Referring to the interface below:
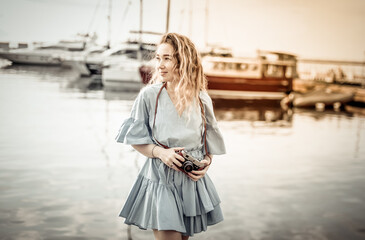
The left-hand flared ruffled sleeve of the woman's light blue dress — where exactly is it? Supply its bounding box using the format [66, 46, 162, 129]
[115, 89, 153, 145]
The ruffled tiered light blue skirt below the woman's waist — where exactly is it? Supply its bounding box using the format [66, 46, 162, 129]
[119, 152, 223, 236]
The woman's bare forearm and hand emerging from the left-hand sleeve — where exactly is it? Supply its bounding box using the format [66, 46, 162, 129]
[132, 144, 185, 171]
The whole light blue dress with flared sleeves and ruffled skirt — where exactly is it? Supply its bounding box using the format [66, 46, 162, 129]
[116, 83, 226, 236]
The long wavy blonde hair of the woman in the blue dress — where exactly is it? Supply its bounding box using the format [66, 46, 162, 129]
[150, 33, 207, 116]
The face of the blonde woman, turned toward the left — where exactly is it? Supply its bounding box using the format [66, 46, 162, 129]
[156, 43, 177, 82]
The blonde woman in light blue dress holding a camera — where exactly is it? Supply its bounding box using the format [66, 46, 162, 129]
[116, 33, 225, 240]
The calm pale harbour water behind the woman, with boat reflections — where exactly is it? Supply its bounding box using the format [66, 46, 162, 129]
[0, 67, 365, 240]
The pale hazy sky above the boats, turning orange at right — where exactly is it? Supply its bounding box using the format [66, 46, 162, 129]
[0, 0, 365, 61]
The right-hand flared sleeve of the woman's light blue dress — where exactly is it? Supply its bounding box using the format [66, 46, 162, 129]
[200, 91, 226, 155]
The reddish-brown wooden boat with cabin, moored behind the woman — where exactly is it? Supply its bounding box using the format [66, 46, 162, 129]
[203, 51, 297, 99]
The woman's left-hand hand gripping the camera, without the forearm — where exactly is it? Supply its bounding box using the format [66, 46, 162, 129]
[155, 147, 185, 171]
